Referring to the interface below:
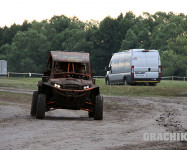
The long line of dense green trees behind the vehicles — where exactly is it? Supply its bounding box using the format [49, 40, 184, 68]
[0, 12, 187, 76]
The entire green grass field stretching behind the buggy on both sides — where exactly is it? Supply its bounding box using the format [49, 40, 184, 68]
[0, 78, 187, 96]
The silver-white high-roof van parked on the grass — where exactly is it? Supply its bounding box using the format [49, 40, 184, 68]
[105, 49, 161, 86]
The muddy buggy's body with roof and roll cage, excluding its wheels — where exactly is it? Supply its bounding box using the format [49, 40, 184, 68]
[38, 51, 100, 111]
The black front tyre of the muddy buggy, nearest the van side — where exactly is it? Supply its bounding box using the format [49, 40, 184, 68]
[94, 95, 103, 120]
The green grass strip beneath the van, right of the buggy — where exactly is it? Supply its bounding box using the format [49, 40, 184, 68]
[96, 79, 187, 96]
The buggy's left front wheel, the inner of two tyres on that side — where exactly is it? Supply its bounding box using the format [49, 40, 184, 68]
[36, 94, 46, 119]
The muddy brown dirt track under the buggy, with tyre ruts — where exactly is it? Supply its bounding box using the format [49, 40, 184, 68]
[0, 87, 187, 150]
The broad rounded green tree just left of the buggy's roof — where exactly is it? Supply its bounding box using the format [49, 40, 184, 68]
[8, 30, 49, 72]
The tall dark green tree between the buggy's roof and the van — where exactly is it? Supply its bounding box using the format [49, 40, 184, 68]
[92, 17, 120, 75]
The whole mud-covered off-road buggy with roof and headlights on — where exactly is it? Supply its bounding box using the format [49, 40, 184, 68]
[31, 51, 103, 120]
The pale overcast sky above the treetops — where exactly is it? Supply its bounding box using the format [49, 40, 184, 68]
[0, 0, 187, 27]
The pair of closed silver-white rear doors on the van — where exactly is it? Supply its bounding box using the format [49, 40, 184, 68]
[132, 50, 159, 79]
